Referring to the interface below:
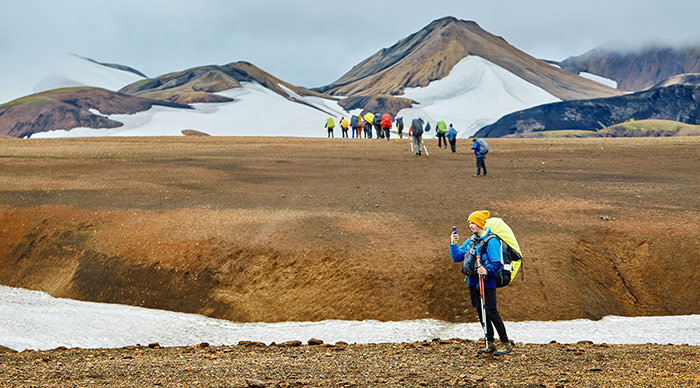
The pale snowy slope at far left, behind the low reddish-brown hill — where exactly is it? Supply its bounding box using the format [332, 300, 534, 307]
[0, 52, 143, 104]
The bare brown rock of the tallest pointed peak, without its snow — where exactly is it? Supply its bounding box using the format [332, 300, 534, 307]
[315, 17, 620, 107]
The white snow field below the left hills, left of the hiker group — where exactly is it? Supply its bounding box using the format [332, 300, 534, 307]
[32, 82, 349, 138]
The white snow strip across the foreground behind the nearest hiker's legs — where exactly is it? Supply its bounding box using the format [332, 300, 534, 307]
[0, 286, 700, 351]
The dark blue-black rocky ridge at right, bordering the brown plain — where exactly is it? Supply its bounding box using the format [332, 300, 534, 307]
[474, 85, 700, 137]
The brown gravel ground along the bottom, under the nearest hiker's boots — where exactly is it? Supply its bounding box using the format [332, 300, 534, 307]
[0, 339, 700, 387]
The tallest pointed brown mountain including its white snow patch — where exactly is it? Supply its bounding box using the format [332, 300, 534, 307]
[315, 17, 620, 137]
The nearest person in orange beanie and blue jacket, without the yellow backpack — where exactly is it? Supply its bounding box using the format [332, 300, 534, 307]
[450, 210, 513, 356]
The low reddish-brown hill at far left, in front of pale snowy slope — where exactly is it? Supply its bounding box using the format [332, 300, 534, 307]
[0, 87, 189, 138]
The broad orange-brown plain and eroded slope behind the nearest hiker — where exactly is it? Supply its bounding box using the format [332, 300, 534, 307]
[0, 136, 700, 321]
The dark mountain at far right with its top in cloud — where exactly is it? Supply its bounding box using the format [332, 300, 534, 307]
[558, 44, 700, 91]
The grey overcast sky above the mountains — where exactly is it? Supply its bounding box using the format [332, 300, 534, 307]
[0, 0, 700, 87]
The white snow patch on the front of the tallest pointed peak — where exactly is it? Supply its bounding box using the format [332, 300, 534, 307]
[397, 55, 561, 137]
